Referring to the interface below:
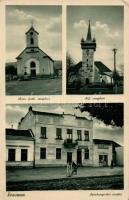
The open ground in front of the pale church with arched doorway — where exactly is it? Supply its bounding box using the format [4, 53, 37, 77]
[6, 78, 62, 95]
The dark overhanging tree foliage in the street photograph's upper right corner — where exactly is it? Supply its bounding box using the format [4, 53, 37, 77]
[76, 103, 124, 127]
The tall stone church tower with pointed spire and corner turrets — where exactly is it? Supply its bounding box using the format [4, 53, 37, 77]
[80, 20, 96, 85]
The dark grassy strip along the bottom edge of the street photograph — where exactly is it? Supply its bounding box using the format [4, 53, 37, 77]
[6, 175, 124, 191]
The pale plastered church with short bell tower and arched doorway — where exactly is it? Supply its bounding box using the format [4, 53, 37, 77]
[16, 25, 54, 78]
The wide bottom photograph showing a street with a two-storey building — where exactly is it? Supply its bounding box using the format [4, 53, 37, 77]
[5, 103, 124, 191]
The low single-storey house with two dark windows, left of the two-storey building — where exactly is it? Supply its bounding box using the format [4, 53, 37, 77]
[6, 129, 34, 167]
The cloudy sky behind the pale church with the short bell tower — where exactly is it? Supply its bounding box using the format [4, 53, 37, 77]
[6, 5, 62, 62]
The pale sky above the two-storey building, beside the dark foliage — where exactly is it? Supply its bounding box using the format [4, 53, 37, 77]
[6, 104, 123, 145]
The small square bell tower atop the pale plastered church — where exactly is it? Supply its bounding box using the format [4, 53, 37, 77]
[26, 25, 39, 47]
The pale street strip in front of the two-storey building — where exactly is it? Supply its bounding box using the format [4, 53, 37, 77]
[6, 167, 123, 182]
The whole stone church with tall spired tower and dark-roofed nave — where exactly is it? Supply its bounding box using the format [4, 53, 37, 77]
[71, 21, 112, 85]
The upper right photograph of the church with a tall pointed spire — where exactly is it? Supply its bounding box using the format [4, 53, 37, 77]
[66, 5, 124, 94]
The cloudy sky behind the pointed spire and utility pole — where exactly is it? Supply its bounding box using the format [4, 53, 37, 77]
[67, 6, 124, 71]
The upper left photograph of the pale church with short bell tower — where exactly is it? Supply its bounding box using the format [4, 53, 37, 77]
[5, 5, 62, 95]
